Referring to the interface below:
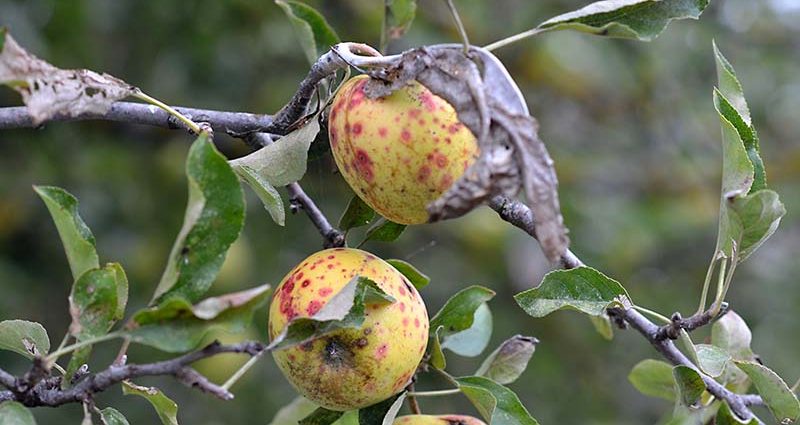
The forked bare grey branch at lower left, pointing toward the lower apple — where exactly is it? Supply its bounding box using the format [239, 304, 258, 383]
[0, 341, 266, 407]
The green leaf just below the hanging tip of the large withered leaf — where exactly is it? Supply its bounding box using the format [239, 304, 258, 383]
[514, 267, 630, 317]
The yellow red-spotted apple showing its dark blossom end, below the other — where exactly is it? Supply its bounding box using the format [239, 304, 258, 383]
[268, 248, 429, 411]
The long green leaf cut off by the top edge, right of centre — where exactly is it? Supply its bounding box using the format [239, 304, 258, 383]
[537, 0, 708, 41]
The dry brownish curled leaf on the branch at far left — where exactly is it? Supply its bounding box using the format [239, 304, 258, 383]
[0, 32, 138, 125]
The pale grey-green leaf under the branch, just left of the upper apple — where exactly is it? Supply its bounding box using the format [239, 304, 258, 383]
[230, 115, 319, 187]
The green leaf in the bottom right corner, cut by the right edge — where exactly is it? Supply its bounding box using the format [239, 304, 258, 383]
[735, 360, 800, 424]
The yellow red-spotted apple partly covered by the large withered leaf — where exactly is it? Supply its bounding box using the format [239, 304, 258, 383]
[328, 75, 479, 224]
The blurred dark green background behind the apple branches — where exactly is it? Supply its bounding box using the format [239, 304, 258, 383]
[0, 0, 800, 425]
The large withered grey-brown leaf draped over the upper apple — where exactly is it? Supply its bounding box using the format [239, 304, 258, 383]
[334, 43, 569, 261]
